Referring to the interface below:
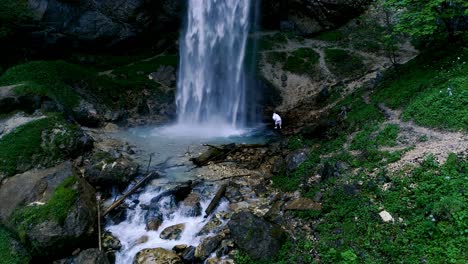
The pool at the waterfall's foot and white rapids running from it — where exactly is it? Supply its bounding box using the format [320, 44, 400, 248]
[105, 125, 273, 264]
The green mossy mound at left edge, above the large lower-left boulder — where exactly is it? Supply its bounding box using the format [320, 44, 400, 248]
[0, 115, 76, 176]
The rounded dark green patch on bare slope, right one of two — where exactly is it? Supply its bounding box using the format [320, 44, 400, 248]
[325, 48, 364, 78]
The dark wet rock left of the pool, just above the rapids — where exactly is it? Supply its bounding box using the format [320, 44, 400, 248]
[84, 152, 139, 189]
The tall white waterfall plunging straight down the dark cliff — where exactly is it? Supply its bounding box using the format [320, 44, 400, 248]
[176, 0, 252, 128]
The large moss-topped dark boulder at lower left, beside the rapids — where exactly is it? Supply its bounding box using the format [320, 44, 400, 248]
[8, 174, 97, 258]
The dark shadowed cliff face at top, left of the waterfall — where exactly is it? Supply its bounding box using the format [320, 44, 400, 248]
[29, 0, 182, 47]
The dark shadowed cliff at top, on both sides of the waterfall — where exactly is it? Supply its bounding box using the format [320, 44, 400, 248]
[23, 0, 371, 47]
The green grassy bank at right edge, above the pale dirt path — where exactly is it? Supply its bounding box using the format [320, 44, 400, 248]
[372, 47, 468, 131]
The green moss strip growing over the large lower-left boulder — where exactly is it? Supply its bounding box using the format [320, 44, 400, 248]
[10, 176, 78, 242]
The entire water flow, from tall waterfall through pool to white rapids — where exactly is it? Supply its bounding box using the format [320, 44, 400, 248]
[106, 0, 266, 264]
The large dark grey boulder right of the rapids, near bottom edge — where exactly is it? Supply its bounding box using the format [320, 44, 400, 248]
[228, 212, 286, 260]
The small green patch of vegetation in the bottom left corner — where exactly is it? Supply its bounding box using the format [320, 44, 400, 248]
[0, 226, 30, 264]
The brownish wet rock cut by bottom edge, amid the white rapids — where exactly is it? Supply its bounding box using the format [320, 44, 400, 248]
[133, 248, 183, 264]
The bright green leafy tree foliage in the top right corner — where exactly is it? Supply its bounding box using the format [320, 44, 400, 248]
[385, 0, 468, 40]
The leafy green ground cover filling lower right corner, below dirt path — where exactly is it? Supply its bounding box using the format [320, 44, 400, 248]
[268, 154, 468, 264]
